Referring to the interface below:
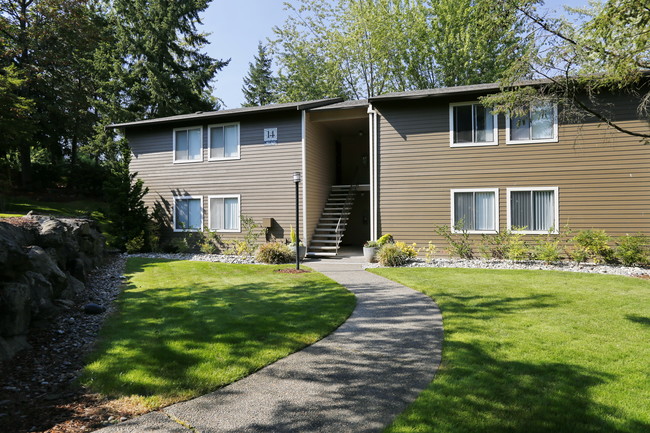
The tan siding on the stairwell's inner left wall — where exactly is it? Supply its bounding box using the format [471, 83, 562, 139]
[305, 113, 336, 246]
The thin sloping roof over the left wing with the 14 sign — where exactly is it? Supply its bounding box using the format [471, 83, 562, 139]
[107, 98, 343, 128]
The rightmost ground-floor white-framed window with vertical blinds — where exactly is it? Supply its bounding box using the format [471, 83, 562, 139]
[507, 186, 559, 234]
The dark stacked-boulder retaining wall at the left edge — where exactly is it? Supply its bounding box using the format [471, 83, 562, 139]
[0, 215, 105, 360]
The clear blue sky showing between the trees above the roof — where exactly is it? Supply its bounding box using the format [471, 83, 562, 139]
[202, 0, 587, 108]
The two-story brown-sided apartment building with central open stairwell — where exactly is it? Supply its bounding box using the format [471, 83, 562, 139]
[113, 80, 650, 253]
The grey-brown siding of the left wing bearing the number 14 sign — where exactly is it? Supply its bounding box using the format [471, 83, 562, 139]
[126, 111, 302, 239]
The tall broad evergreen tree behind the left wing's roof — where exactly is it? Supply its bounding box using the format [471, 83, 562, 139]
[97, 0, 229, 122]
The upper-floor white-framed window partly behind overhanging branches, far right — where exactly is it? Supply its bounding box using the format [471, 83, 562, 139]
[506, 102, 558, 144]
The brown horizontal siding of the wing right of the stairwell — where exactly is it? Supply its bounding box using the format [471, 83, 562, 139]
[376, 98, 650, 252]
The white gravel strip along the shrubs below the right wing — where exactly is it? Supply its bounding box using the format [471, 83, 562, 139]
[365, 259, 650, 277]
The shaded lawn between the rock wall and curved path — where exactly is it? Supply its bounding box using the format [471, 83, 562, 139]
[82, 258, 355, 409]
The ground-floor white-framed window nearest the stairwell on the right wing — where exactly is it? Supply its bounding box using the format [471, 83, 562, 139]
[451, 188, 499, 233]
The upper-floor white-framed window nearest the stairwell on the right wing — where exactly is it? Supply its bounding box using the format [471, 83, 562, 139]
[449, 102, 499, 147]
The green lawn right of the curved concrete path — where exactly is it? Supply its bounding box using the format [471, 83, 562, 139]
[372, 268, 650, 433]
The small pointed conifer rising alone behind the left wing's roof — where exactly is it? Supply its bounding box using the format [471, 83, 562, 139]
[242, 42, 277, 107]
